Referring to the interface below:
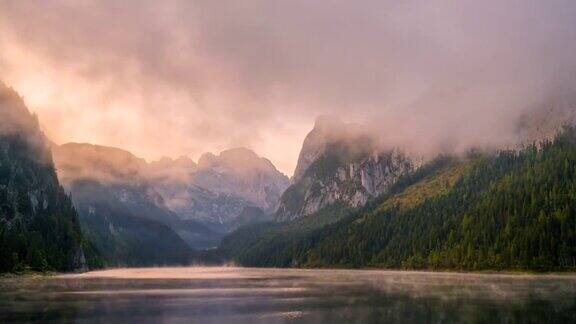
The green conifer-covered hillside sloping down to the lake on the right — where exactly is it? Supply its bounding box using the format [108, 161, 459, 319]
[223, 127, 576, 270]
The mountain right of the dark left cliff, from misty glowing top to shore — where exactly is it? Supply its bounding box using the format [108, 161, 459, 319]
[53, 143, 219, 266]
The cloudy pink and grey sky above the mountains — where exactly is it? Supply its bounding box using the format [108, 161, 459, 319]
[0, 0, 576, 175]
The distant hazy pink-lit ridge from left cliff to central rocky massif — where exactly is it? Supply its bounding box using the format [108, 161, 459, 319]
[54, 143, 288, 233]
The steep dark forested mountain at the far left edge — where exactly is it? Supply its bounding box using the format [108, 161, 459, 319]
[0, 83, 100, 272]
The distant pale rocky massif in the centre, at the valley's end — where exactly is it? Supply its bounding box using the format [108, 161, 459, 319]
[150, 148, 289, 232]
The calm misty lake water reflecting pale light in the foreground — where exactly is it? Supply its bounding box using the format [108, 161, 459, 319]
[0, 268, 576, 323]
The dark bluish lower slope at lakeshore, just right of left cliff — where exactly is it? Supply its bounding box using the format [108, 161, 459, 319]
[70, 179, 194, 266]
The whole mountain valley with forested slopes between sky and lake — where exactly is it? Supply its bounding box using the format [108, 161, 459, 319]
[0, 79, 576, 271]
